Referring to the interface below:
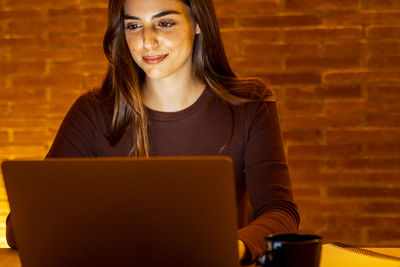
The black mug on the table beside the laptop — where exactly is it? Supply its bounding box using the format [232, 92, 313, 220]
[258, 234, 322, 267]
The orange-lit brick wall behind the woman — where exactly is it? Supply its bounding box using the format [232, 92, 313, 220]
[0, 0, 400, 246]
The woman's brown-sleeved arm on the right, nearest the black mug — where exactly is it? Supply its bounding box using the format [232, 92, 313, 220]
[239, 102, 300, 262]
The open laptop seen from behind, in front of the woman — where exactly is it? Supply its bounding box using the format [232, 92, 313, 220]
[2, 156, 239, 267]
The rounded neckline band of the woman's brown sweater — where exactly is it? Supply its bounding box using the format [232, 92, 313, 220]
[145, 86, 209, 121]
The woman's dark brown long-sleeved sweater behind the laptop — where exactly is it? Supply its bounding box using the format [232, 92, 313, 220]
[7, 88, 299, 260]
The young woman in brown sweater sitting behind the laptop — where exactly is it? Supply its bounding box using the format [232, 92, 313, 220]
[7, 0, 299, 262]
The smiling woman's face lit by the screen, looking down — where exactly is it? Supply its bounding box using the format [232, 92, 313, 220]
[124, 0, 199, 79]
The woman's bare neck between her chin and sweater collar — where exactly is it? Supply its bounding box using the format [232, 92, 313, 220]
[143, 69, 205, 112]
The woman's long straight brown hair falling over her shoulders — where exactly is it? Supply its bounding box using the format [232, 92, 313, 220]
[102, 0, 273, 156]
